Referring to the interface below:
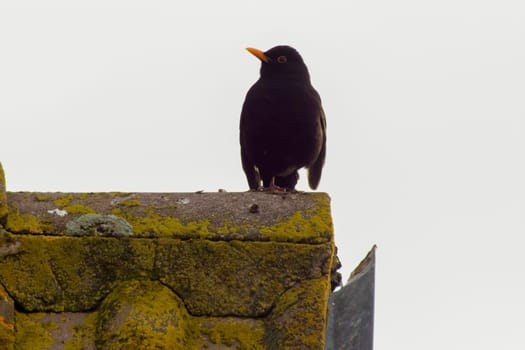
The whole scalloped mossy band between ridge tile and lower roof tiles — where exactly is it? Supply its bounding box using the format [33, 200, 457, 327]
[0, 230, 333, 317]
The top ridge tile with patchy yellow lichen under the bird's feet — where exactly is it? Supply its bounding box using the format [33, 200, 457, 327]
[3, 192, 333, 244]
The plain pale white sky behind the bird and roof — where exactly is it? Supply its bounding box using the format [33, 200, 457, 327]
[0, 0, 525, 350]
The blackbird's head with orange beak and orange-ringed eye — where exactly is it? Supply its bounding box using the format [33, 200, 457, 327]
[246, 45, 310, 81]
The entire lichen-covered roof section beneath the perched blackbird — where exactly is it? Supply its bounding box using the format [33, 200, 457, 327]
[0, 165, 336, 349]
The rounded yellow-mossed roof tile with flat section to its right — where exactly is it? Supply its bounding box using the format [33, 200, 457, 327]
[96, 280, 264, 350]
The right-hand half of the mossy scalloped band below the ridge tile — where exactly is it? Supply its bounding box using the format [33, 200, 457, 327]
[155, 239, 332, 317]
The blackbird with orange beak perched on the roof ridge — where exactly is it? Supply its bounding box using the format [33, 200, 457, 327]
[240, 46, 326, 192]
